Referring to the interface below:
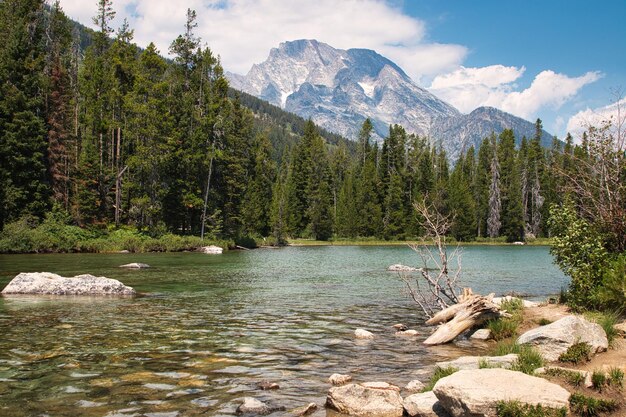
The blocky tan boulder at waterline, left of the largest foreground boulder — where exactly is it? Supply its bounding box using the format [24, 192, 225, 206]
[326, 382, 403, 417]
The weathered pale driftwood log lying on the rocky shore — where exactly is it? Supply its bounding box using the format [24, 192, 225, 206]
[424, 291, 510, 345]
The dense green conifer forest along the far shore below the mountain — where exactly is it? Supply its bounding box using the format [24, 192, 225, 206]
[0, 0, 588, 247]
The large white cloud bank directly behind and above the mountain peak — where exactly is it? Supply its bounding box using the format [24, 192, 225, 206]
[61, 0, 467, 81]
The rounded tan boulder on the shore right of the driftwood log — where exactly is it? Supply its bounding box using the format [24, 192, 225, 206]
[517, 316, 609, 361]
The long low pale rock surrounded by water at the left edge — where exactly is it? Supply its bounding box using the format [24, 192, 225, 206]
[2, 272, 135, 295]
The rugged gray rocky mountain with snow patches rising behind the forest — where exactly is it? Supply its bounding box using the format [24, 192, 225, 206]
[227, 40, 551, 160]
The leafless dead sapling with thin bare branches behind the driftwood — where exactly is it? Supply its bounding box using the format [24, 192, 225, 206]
[400, 197, 461, 318]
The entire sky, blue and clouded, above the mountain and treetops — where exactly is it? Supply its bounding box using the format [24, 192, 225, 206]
[60, 0, 626, 138]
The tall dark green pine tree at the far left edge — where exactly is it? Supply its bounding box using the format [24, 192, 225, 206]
[0, 0, 48, 228]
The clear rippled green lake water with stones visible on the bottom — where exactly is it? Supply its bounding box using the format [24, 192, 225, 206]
[0, 246, 567, 417]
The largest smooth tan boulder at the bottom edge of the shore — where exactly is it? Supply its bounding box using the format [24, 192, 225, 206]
[433, 369, 569, 417]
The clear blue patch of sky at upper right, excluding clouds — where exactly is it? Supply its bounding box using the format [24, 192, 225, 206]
[402, 0, 626, 133]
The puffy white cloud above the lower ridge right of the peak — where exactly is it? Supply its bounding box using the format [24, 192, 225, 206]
[430, 65, 601, 119]
